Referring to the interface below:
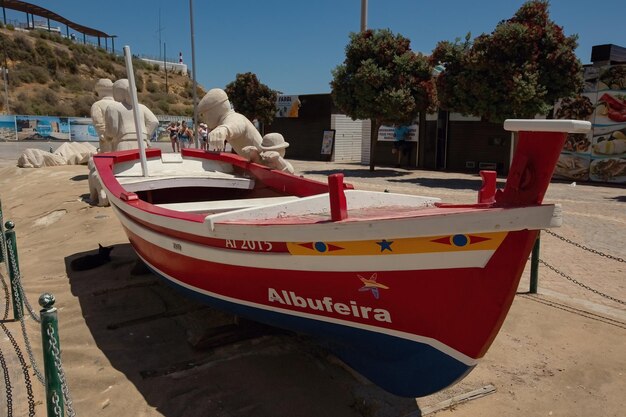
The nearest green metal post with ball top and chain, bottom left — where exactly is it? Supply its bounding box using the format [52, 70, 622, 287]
[39, 293, 65, 417]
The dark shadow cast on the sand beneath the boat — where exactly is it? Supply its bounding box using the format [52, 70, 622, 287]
[65, 244, 420, 417]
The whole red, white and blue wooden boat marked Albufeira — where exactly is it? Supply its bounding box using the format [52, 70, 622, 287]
[94, 120, 590, 397]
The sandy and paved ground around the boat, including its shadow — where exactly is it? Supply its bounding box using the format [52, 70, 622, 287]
[0, 144, 626, 417]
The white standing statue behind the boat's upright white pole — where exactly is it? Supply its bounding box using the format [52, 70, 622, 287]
[104, 78, 159, 151]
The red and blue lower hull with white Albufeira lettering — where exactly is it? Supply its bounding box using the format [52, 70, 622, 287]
[115, 207, 536, 397]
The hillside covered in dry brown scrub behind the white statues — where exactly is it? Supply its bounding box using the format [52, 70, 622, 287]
[0, 27, 204, 116]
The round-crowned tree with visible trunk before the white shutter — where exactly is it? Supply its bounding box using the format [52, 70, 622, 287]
[330, 29, 436, 170]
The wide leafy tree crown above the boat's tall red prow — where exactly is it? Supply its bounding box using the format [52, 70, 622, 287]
[431, 0, 582, 122]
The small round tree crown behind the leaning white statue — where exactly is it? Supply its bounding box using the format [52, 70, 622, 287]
[224, 72, 278, 124]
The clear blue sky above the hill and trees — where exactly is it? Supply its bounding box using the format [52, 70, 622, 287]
[7, 0, 626, 94]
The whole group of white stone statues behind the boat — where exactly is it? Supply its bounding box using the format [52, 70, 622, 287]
[89, 79, 294, 206]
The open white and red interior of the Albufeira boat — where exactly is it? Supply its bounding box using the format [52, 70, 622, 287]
[107, 154, 439, 217]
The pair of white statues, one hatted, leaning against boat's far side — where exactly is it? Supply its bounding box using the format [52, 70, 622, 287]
[198, 88, 293, 173]
